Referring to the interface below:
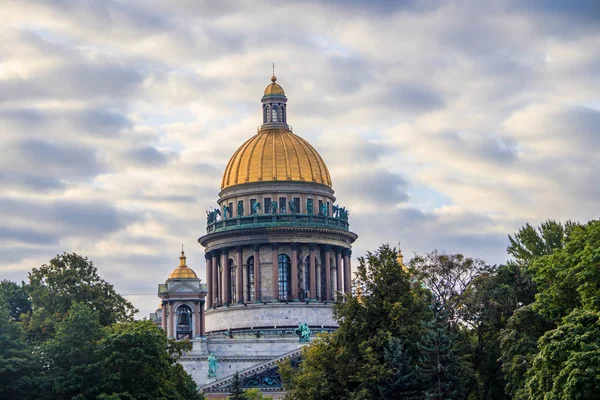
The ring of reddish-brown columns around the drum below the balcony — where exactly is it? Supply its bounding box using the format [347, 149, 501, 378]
[205, 243, 352, 308]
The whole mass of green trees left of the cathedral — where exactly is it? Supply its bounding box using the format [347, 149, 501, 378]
[0, 253, 203, 400]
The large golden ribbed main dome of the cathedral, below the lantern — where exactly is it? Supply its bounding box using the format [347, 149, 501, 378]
[221, 129, 331, 189]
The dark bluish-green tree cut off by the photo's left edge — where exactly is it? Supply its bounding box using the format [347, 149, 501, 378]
[0, 307, 33, 399]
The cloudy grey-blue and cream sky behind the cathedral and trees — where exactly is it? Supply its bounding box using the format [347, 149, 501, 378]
[0, 0, 600, 315]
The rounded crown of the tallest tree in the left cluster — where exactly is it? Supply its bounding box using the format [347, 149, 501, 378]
[23, 253, 137, 342]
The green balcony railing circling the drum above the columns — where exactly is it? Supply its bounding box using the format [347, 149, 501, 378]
[206, 214, 349, 233]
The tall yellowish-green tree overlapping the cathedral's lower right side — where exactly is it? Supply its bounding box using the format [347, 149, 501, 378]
[280, 245, 431, 399]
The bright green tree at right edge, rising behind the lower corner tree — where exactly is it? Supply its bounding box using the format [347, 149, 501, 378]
[501, 221, 600, 399]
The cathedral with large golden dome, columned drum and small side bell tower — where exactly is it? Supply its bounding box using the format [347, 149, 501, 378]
[151, 76, 357, 398]
